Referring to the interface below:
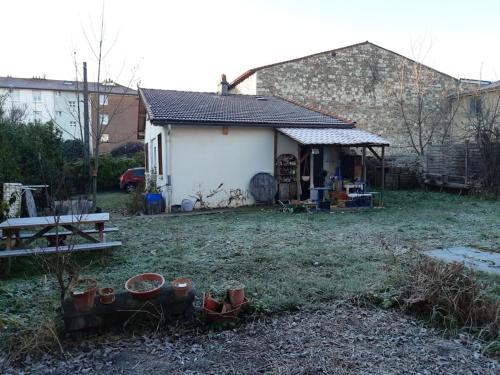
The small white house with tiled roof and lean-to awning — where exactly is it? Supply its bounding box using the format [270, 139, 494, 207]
[138, 77, 388, 210]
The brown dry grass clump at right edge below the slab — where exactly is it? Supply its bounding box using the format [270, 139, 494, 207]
[403, 257, 500, 340]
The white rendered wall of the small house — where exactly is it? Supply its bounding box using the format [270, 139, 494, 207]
[144, 121, 274, 207]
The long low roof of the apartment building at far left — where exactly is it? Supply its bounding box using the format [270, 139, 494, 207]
[0, 77, 137, 95]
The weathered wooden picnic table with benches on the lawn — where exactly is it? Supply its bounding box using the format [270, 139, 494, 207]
[0, 213, 122, 274]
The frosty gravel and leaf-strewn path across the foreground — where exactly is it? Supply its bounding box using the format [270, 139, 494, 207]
[3, 306, 500, 375]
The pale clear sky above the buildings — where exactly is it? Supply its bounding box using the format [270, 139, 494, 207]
[0, 0, 500, 91]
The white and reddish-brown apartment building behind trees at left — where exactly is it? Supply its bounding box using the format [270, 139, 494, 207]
[0, 77, 138, 152]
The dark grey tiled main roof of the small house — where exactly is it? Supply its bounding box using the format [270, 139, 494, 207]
[139, 89, 354, 128]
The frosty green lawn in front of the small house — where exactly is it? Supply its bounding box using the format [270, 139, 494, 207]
[0, 191, 500, 342]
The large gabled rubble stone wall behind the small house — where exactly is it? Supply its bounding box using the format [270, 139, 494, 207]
[233, 42, 458, 155]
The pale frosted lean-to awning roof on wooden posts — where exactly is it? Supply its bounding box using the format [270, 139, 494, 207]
[278, 128, 389, 146]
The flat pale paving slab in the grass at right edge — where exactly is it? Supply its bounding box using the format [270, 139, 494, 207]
[425, 246, 500, 275]
